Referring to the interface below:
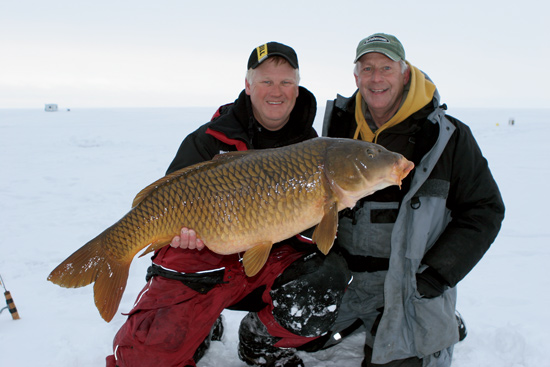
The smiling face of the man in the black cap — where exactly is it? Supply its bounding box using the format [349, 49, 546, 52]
[245, 59, 298, 131]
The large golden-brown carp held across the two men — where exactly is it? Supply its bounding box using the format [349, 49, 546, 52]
[48, 138, 414, 322]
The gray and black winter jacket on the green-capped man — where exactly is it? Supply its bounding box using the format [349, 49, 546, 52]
[323, 84, 504, 366]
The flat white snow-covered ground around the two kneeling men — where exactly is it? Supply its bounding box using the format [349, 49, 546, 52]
[0, 107, 550, 367]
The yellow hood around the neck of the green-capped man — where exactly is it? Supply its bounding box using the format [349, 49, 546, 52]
[353, 62, 435, 143]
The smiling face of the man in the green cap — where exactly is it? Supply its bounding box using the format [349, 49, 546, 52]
[355, 52, 410, 126]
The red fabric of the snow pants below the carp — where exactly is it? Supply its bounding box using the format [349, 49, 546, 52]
[107, 245, 315, 367]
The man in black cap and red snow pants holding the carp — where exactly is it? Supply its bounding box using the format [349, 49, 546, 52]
[107, 42, 350, 367]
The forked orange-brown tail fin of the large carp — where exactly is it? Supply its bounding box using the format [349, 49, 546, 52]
[48, 232, 133, 322]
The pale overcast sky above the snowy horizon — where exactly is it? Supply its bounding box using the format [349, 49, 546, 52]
[0, 0, 550, 108]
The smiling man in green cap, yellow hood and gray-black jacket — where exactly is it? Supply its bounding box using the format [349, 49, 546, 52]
[316, 33, 504, 367]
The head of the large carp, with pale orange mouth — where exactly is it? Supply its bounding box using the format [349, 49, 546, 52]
[325, 139, 414, 210]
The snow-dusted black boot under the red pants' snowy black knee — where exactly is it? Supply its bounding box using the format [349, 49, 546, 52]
[239, 312, 304, 367]
